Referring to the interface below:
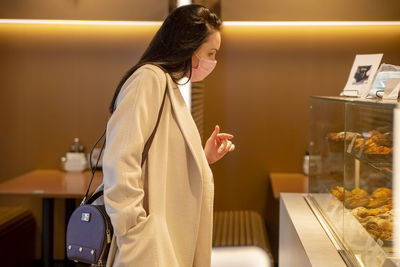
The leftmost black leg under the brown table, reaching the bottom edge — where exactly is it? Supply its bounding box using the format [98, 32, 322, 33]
[42, 198, 54, 267]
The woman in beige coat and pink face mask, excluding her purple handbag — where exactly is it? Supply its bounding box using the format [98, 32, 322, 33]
[103, 5, 235, 267]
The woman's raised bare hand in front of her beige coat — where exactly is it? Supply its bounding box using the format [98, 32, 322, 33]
[204, 125, 235, 164]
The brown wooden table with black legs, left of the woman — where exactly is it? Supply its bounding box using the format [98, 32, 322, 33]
[0, 170, 103, 267]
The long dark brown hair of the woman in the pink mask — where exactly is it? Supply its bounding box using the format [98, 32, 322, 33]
[110, 5, 222, 113]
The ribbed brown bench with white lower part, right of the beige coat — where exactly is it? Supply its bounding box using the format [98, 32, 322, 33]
[211, 210, 273, 267]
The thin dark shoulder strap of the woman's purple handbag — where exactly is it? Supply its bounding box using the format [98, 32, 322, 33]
[80, 76, 168, 205]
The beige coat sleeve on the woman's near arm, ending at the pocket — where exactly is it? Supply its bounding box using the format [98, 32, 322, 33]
[103, 66, 166, 237]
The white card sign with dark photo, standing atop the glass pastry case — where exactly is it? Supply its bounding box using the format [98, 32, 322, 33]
[341, 54, 383, 98]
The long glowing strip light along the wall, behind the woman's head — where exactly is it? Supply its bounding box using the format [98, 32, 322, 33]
[0, 19, 400, 27]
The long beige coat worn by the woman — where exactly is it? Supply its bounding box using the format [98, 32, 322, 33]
[103, 65, 214, 267]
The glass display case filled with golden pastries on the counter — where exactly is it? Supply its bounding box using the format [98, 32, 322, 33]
[306, 97, 400, 266]
